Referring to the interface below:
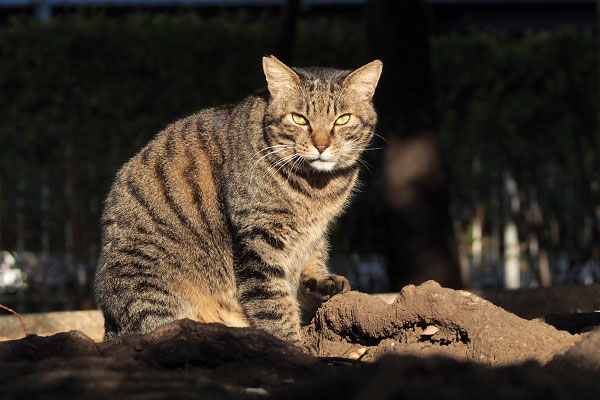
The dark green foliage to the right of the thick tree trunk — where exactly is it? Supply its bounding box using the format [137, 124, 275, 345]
[432, 31, 599, 181]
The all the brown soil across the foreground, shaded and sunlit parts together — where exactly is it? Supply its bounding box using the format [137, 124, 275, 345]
[0, 281, 600, 400]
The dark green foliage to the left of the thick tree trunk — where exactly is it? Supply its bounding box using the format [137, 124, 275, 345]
[0, 12, 362, 253]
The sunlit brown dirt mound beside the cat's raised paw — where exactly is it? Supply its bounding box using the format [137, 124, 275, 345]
[303, 281, 579, 365]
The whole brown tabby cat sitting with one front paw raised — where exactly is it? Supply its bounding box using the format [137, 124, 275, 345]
[94, 56, 383, 343]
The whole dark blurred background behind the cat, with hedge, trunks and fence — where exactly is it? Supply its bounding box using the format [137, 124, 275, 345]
[0, 0, 600, 312]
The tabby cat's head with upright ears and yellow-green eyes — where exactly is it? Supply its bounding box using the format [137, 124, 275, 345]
[263, 56, 383, 172]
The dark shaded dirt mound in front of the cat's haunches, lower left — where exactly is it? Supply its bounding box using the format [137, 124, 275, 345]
[0, 320, 325, 399]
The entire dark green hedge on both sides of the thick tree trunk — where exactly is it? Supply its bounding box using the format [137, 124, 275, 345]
[0, 13, 600, 288]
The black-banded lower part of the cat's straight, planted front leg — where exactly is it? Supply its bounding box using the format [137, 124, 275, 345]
[235, 249, 301, 344]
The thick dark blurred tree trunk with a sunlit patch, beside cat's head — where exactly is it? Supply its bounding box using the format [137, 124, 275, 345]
[367, 0, 461, 290]
